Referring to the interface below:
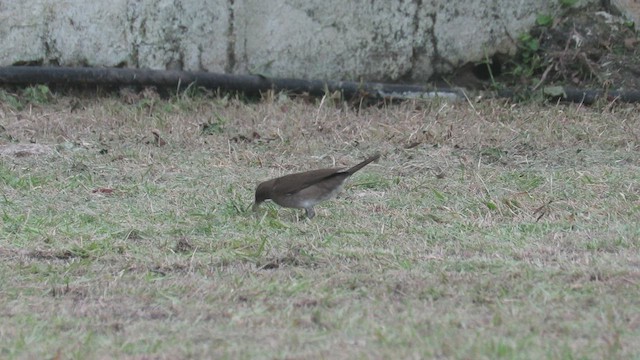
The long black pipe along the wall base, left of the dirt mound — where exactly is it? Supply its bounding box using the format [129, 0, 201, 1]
[0, 66, 464, 99]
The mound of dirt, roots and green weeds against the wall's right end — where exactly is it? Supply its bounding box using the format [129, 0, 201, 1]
[456, 4, 640, 93]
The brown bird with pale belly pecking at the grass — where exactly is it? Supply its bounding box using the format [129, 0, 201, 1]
[253, 154, 380, 219]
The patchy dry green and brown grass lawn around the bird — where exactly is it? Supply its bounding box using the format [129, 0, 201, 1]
[0, 91, 640, 359]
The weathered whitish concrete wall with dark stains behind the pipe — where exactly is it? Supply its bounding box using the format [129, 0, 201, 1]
[0, 0, 600, 81]
